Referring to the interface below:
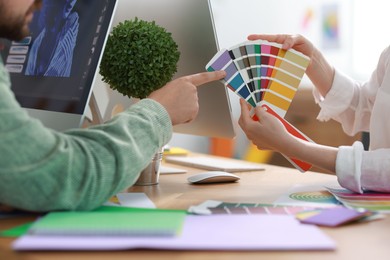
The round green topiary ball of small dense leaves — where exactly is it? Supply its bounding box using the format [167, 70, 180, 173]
[100, 18, 180, 98]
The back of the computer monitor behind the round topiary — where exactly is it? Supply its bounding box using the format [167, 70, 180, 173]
[100, 0, 235, 138]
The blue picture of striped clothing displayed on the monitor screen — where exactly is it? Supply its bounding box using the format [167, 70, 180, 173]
[25, 0, 79, 77]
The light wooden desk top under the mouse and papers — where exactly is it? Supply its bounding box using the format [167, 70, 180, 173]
[0, 155, 390, 260]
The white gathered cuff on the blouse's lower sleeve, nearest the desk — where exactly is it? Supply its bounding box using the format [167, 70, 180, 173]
[336, 141, 364, 193]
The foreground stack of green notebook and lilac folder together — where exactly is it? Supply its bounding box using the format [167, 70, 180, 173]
[7, 194, 336, 251]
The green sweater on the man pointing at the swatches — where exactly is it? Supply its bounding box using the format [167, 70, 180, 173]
[0, 60, 172, 211]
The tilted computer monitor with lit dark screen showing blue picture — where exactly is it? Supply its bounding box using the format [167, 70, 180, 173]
[0, 0, 117, 130]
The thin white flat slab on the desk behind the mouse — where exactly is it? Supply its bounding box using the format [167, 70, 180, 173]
[165, 156, 265, 172]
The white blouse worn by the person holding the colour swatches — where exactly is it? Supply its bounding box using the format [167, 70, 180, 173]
[313, 47, 390, 193]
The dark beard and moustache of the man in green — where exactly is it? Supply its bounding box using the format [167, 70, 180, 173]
[0, 0, 42, 41]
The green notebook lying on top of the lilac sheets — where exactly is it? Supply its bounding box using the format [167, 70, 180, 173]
[28, 207, 186, 236]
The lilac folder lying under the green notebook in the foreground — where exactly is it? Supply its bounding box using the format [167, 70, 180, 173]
[13, 215, 336, 250]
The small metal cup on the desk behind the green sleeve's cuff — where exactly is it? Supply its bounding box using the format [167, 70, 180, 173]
[134, 150, 163, 186]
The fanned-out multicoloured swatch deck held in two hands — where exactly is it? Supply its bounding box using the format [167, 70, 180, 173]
[206, 40, 312, 172]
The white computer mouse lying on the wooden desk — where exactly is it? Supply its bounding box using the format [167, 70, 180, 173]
[187, 171, 240, 184]
